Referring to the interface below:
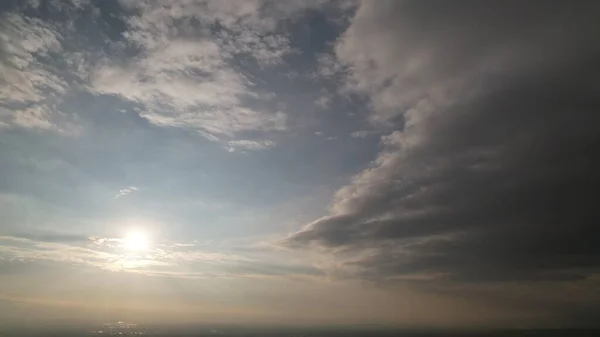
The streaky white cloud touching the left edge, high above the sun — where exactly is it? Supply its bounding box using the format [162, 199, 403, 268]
[0, 13, 82, 136]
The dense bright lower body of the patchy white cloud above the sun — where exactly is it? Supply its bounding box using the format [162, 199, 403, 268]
[92, 40, 278, 135]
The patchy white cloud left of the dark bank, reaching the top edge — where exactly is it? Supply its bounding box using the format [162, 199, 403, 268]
[90, 1, 314, 138]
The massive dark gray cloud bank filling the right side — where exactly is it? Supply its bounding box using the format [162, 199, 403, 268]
[286, 1, 600, 282]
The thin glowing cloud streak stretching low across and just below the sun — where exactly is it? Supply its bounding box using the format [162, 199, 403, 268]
[0, 235, 322, 278]
